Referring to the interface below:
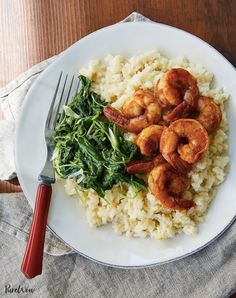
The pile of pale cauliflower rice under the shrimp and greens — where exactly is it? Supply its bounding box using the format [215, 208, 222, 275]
[65, 50, 229, 239]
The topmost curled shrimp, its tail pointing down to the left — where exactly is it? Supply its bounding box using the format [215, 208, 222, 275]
[155, 68, 199, 121]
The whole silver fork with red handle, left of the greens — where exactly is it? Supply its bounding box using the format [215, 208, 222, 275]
[21, 72, 75, 278]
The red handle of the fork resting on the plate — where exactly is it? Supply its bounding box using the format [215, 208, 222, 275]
[21, 184, 52, 278]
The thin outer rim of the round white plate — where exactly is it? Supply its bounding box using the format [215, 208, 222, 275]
[14, 21, 236, 269]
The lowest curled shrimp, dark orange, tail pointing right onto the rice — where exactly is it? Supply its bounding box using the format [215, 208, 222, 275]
[148, 163, 193, 211]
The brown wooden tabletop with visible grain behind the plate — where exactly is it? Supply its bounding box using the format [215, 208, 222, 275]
[0, 0, 236, 192]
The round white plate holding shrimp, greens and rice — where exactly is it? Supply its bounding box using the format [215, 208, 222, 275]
[16, 23, 236, 268]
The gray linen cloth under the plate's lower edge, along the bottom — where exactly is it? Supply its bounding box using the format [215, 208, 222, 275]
[0, 224, 236, 298]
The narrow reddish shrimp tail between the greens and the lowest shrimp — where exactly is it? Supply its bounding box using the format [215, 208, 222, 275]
[126, 154, 166, 174]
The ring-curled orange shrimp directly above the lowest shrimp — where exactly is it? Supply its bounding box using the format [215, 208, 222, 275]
[160, 119, 209, 172]
